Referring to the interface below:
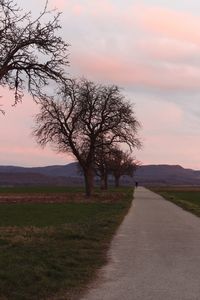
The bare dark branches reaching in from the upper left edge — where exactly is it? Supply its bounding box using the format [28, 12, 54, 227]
[0, 0, 68, 102]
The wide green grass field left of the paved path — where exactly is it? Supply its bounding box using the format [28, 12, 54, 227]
[0, 188, 133, 300]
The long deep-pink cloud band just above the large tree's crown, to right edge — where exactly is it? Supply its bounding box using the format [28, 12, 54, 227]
[73, 54, 200, 90]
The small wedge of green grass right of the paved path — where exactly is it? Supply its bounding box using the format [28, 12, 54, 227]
[151, 187, 200, 217]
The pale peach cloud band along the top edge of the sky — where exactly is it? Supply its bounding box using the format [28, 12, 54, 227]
[50, 0, 200, 49]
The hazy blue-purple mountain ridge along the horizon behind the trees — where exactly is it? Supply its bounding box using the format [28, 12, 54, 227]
[0, 162, 200, 186]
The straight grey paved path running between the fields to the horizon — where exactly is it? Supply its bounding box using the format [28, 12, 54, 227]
[82, 187, 200, 300]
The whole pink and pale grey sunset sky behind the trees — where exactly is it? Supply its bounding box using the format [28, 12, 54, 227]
[0, 0, 200, 169]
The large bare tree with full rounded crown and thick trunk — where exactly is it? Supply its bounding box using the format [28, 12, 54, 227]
[33, 79, 139, 196]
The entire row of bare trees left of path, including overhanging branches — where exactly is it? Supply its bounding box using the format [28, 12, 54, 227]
[0, 0, 141, 196]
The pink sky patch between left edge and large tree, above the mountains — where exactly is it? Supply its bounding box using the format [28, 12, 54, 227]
[0, 89, 73, 166]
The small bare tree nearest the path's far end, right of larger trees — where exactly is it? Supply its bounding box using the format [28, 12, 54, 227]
[108, 147, 139, 187]
